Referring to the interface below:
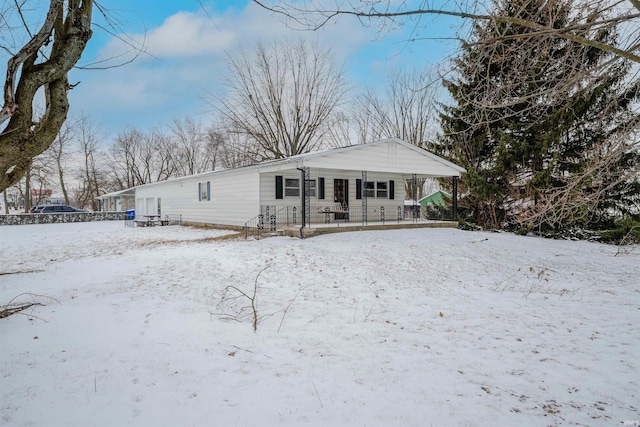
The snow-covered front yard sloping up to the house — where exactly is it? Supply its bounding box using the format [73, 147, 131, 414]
[0, 222, 640, 426]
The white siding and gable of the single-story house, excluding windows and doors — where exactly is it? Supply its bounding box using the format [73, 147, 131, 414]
[135, 139, 463, 226]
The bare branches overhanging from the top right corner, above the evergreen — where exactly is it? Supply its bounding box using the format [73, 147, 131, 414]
[253, 0, 640, 63]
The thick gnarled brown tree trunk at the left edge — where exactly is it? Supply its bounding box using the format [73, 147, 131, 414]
[0, 0, 94, 191]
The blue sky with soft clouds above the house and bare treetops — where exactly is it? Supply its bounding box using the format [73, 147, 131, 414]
[69, 0, 456, 135]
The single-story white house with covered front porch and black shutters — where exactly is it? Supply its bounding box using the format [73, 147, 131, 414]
[135, 139, 464, 231]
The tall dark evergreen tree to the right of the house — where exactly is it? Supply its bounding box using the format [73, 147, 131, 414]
[438, 0, 640, 237]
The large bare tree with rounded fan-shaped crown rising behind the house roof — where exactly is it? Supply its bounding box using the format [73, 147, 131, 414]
[211, 41, 347, 162]
